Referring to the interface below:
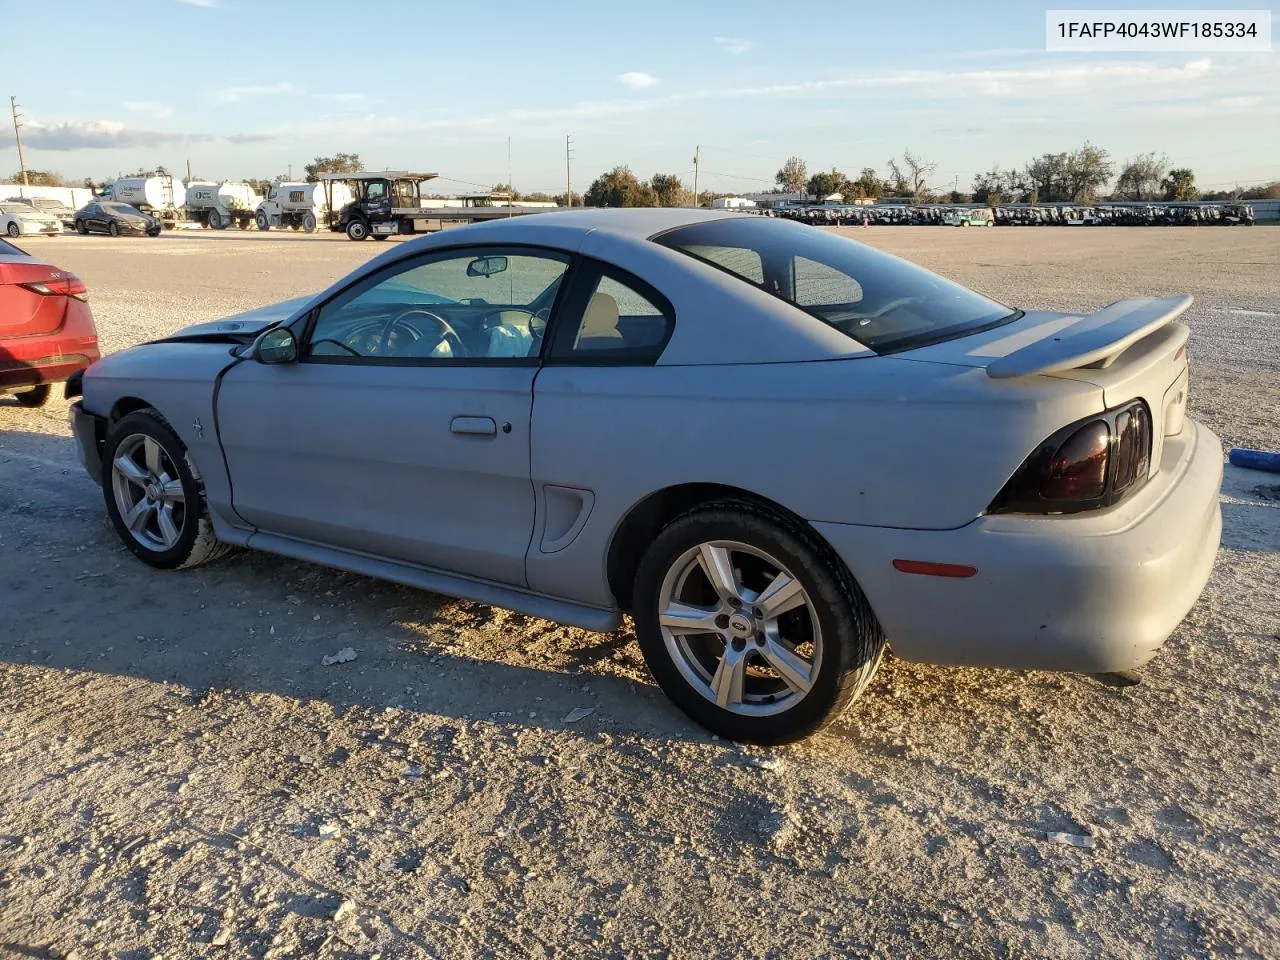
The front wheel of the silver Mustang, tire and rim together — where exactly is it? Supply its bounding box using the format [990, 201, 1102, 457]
[102, 410, 230, 570]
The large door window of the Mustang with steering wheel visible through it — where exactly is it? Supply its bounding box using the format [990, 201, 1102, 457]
[305, 247, 570, 362]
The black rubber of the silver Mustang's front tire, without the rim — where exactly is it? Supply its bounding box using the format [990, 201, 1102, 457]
[102, 408, 233, 570]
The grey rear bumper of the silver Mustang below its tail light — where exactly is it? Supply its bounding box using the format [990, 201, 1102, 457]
[814, 420, 1222, 673]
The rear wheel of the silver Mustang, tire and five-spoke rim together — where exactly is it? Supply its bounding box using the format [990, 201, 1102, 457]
[634, 502, 884, 744]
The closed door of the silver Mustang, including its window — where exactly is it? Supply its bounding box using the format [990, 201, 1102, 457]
[218, 241, 570, 586]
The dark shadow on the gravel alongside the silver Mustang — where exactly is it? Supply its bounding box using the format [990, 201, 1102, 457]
[0, 424, 709, 741]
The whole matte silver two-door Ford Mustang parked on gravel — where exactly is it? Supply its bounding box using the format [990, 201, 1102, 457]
[68, 210, 1222, 742]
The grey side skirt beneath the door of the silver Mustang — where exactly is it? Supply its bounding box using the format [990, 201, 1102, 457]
[234, 531, 622, 634]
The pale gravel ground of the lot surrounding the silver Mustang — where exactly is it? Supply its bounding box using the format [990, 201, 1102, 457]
[0, 227, 1280, 960]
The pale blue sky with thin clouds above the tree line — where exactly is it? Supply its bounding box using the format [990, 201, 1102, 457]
[0, 0, 1280, 193]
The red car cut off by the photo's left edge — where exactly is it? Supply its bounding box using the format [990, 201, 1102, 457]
[0, 241, 100, 407]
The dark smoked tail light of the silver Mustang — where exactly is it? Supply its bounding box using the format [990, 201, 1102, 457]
[987, 401, 1152, 513]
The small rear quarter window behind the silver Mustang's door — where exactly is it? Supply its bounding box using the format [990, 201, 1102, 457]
[554, 265, 675, 365]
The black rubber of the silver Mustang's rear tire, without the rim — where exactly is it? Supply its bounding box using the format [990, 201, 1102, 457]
[632, 500, 884, 745]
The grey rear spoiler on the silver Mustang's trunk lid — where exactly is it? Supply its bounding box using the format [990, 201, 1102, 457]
[987, 297, 1192, 380]
